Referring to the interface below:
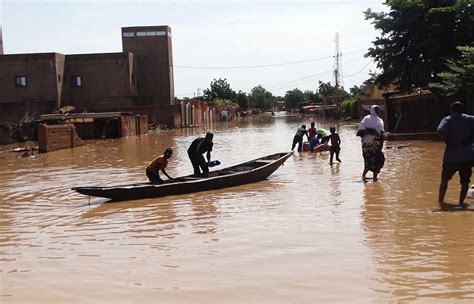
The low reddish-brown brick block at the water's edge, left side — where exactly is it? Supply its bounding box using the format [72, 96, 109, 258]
[38, 124, 84, 153]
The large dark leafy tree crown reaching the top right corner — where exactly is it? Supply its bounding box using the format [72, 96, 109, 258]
[365, 0, 474, 92]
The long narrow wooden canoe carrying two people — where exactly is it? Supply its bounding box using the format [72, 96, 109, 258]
[72, 152, 293, 201]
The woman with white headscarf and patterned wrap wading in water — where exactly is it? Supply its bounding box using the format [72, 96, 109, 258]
[357, 105, 385, 182]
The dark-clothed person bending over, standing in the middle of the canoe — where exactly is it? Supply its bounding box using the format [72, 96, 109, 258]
[188, 132, 214, 176]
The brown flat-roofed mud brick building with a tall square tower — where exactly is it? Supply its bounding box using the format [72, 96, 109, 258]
[0, 26, 174, 122]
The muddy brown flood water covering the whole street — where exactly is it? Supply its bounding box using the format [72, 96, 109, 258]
[0, 115, 474, 303]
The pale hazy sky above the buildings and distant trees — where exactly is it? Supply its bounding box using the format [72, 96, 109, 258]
[0, 0, 386, 97]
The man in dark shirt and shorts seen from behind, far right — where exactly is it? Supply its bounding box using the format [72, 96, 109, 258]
[438, 101, 474, 207]
